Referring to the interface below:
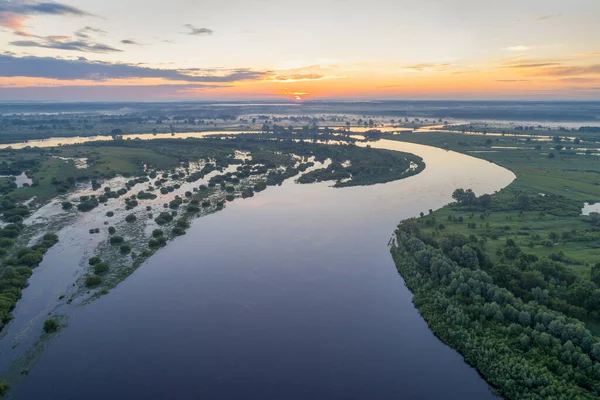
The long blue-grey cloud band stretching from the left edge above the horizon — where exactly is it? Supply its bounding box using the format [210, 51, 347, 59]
[0, 54, 272, 83]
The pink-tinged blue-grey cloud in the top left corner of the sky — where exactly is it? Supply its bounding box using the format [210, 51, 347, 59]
[0, 0, 94, 32]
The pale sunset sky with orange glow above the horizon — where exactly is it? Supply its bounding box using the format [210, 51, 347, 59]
[0, 0, 600, 101]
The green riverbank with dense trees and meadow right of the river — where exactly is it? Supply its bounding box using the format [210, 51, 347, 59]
[392, 132, 600, 399]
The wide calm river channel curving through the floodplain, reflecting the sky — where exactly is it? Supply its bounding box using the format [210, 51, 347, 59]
[3, 140, 514, 400]
